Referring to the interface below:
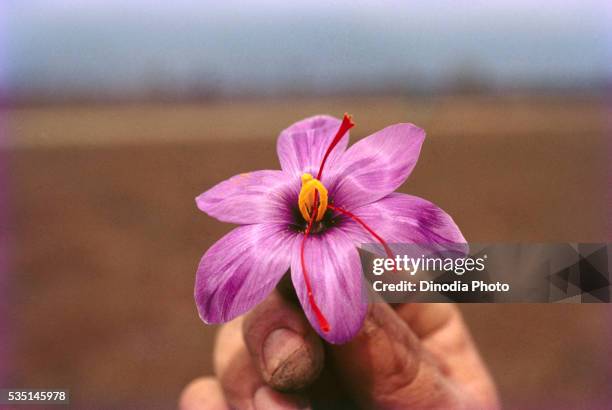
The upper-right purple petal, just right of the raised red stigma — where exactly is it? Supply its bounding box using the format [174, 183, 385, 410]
[328, 124, 425, 210]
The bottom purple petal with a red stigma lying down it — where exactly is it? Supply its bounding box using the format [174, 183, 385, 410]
[291, 229, 367, 343]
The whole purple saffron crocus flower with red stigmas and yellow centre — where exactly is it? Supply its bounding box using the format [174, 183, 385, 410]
[195, 114, 465, 344]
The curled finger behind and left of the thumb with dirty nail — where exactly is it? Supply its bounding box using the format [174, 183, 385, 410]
[214, 318, 305, 410]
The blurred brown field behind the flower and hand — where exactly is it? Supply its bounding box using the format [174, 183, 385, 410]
[3, 96, 612, 409]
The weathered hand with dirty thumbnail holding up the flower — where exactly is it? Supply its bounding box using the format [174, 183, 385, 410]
[179, 291, 499, 410]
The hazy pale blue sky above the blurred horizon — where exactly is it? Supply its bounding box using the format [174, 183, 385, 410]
[0, 0, 612, 95]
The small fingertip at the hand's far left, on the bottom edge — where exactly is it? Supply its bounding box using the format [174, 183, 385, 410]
[179, 377, 230, 410]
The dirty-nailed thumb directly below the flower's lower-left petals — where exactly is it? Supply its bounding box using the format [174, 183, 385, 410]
[243, 292, 324, 391]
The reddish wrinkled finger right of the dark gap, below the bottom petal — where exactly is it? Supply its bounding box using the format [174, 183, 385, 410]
[330, 303, 458, 408]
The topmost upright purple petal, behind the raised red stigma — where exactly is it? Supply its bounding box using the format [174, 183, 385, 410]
[276, 115, 349, 177]
